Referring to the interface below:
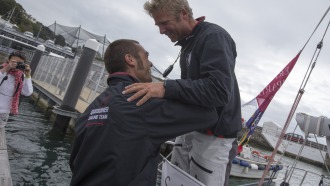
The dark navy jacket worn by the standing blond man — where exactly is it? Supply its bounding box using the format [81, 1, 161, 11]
[165, 17, 242, 137]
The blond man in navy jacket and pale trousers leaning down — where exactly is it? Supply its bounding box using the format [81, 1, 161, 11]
[124, 0, 242, 186]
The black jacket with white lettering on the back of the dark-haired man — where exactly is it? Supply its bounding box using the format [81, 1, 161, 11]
[70, 73, 217, 186]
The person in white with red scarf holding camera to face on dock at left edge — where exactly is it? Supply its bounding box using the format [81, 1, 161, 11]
[0, 51, 33, 128]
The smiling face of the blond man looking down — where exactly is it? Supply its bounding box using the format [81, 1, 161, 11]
[152, 11, 189, 42]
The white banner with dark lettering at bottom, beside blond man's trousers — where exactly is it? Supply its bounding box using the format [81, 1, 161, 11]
[161, 158, 205, 186]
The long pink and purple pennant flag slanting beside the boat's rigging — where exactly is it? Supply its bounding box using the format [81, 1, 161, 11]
[239, 51, 301, 146]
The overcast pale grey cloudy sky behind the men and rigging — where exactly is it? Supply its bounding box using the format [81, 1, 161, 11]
[16, 0, 330, 141]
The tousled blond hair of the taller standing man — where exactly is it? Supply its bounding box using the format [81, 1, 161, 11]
[144, 0, 193, 19]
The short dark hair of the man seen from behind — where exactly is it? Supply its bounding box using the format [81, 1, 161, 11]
[104, 39, 139, 73]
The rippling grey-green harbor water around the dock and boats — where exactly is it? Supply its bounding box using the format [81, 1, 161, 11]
[6, 98, 328, 186]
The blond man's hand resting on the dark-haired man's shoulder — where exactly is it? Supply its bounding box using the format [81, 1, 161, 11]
[123, 82, 165, 106]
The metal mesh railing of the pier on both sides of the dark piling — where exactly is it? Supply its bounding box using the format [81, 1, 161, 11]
[33, 55, 108, 107]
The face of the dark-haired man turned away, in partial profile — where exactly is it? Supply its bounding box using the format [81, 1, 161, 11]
[136, 45, 152, 83]
